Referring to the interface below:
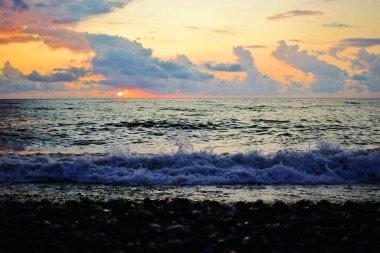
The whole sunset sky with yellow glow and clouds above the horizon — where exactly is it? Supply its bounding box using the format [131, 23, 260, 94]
[0, 0, 380, 99]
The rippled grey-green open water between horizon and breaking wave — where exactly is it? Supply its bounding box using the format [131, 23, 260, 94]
[0, 99, 380, 154]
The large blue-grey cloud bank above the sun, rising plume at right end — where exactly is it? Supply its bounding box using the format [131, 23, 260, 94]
[83, 34, 283, 96]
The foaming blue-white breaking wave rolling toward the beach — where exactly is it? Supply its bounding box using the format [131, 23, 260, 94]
[0, 147, 380, 186]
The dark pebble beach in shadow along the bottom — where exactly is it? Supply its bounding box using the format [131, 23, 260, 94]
[0, 198, 380, 252]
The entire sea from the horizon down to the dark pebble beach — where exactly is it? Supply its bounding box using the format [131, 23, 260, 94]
[0, 99, 380, 203]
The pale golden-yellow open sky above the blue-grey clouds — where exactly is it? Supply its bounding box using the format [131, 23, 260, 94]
[78, 0, 380, 61]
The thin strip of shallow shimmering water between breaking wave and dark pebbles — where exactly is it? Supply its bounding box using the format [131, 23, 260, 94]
[0, 183, 380, 204]
